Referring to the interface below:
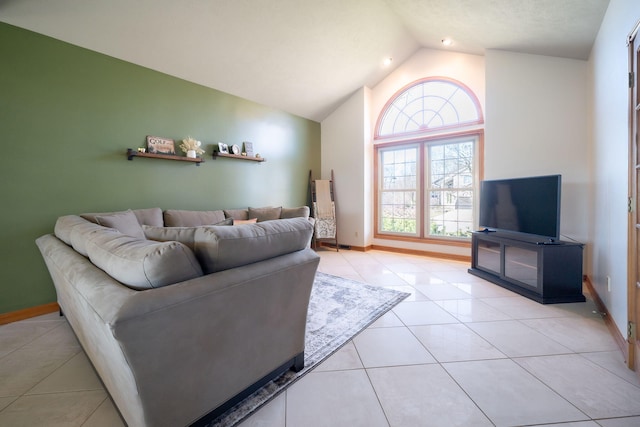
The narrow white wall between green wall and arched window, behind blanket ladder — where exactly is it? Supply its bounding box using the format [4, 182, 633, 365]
[320, 87, 373, 247]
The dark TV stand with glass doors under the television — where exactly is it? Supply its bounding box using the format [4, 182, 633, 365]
[468, 231, 585, 304]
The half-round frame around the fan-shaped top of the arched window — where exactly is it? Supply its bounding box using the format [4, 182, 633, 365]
[374, 76, 484, 140]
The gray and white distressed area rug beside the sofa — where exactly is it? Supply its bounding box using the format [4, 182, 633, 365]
[208, 272, 409, 427]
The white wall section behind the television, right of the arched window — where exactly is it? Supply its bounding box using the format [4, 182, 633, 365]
[484, 50, 591, 249]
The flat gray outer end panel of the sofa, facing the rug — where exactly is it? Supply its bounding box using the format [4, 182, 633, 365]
[112, 249, 319, 426]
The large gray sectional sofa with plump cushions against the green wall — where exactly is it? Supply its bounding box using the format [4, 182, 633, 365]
[36, 207, 319, 427]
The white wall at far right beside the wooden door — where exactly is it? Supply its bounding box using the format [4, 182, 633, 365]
[588, 0, 640, 337]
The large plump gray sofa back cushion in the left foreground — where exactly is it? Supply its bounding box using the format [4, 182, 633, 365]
[85, 228, 202, 290]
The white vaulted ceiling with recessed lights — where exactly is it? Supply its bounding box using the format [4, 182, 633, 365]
[0, 0, 609, 121]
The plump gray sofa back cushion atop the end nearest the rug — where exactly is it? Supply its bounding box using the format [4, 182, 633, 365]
[194, 218, 313, 274]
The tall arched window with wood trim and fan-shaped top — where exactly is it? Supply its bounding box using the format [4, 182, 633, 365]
[375, 77, 484, 240]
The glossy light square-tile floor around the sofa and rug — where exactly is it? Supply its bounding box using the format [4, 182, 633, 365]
[0, 250, 640, 427]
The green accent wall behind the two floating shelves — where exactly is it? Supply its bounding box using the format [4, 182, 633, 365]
[0, 23, 320, 313]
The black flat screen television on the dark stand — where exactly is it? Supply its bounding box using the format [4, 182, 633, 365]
[479, 175, 562, 241]
